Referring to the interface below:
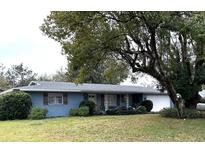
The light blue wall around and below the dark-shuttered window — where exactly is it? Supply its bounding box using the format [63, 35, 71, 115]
[30, 92, 84, 117]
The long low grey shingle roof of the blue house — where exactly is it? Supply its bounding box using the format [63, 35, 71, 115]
[12, 81, 165, 94]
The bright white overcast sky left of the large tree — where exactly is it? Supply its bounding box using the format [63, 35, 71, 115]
[0, 4, 66, 74]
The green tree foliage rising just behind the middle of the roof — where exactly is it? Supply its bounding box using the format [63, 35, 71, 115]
[66, 52, 129, 84]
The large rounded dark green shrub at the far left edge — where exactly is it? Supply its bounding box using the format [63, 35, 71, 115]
[0, 92, 32, 120]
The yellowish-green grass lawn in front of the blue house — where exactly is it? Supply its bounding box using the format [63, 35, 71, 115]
[0, 114, 205, 141]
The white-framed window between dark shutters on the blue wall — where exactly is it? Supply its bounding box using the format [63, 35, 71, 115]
[48, 93, 63, 105]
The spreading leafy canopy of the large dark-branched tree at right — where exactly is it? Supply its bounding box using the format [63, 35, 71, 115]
[41, 11, 205, 115]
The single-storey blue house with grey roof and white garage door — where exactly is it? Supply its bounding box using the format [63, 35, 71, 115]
[0, 81, 173, 116]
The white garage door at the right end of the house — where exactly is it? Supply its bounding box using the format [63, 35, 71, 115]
[144, 94, 171, 111]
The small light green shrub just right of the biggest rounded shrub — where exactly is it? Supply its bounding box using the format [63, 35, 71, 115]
[28, 107, 48, 120]
